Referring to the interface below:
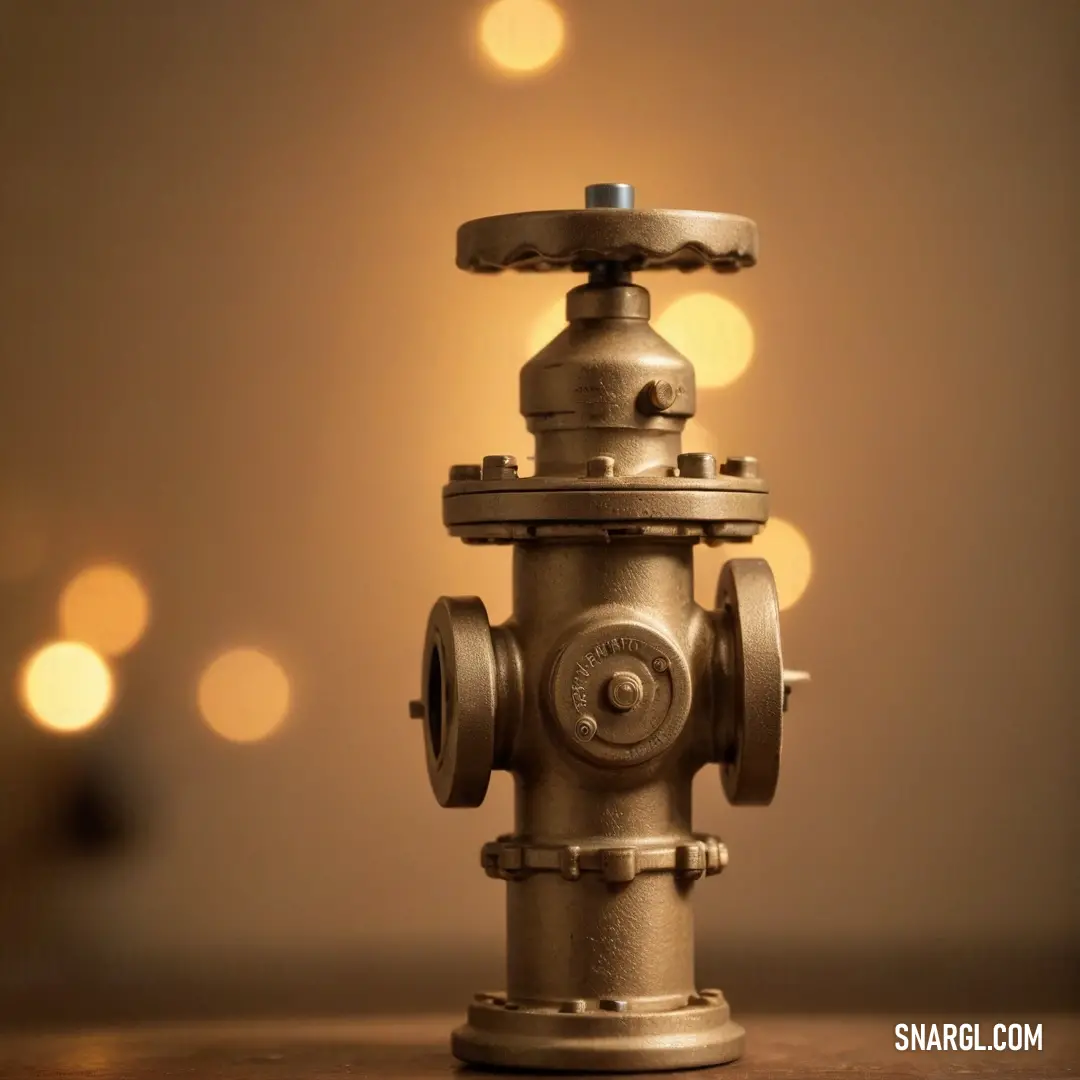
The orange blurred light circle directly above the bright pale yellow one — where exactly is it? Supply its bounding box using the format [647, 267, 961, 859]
[59, 566, 150, 657]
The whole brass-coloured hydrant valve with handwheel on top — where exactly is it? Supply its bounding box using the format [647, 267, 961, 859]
[411, 184, 805, 1071]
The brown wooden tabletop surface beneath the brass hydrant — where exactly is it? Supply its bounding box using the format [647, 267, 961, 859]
[0, 1016, 1080, 1080]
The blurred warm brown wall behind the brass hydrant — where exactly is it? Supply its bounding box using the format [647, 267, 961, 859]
[0, 0, 1080, 1010]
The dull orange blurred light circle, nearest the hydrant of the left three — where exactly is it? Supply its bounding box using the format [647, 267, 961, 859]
[199, 649, 291, 743]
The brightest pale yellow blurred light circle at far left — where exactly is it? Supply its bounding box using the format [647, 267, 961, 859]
[19, 642, 113, 733]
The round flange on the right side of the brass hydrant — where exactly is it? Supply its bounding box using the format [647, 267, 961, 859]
[716, 558, 785, 806]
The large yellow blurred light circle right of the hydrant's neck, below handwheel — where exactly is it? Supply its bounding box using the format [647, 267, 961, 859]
[656, 293, 754, 389]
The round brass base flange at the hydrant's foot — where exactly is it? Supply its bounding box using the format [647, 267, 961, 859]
[450, 990, 746, 1072]
